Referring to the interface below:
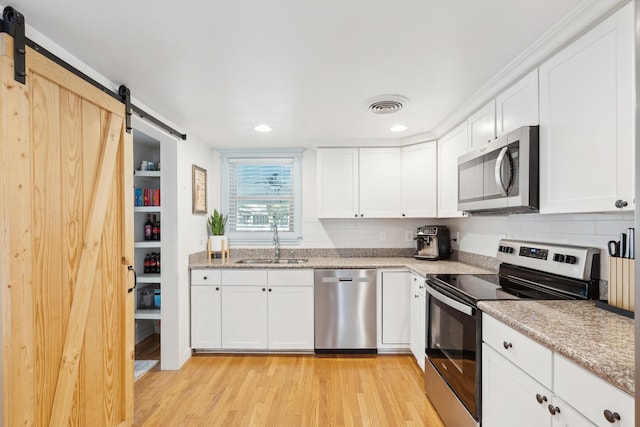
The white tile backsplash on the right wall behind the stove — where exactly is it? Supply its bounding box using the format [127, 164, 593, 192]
[447, 212, 634, 280]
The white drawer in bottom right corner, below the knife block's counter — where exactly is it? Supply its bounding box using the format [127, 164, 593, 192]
[553, 354, 635, 426]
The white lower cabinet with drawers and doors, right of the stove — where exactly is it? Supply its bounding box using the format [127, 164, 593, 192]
[482, 314, 635, 427]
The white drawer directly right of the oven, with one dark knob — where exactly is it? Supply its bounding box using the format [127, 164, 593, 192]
[482, 313, 553, 388]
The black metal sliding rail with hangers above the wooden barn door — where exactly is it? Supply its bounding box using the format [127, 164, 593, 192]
[0, 6, 187, 141]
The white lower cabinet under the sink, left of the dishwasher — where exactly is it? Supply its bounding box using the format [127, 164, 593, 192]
[191, 269, 314, 351]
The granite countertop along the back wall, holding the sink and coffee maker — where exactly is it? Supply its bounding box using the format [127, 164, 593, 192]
[189, 252, 494, 276]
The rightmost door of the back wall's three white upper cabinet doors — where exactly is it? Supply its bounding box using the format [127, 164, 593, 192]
[400, 141, 438, 218]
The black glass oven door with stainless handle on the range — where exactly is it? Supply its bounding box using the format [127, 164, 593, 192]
[425, 280, 480, 419]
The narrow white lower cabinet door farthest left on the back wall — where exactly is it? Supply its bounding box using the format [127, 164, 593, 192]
[191, 286, 222, 349]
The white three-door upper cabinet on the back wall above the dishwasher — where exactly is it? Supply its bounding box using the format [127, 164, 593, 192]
[317, 148, 437, 218]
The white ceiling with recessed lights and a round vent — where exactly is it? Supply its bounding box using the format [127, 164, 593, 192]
[5, 0, 604, 148]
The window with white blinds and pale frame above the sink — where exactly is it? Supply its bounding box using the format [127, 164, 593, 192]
[221, 149, 302, 244]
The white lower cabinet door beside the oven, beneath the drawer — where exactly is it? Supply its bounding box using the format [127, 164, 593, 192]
[482, 343, 551, 427]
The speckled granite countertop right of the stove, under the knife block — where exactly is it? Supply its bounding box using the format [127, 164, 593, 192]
[478, 300, 635, 395]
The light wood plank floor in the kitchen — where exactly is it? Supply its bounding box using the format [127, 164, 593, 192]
[135, 355, 443, 427]
